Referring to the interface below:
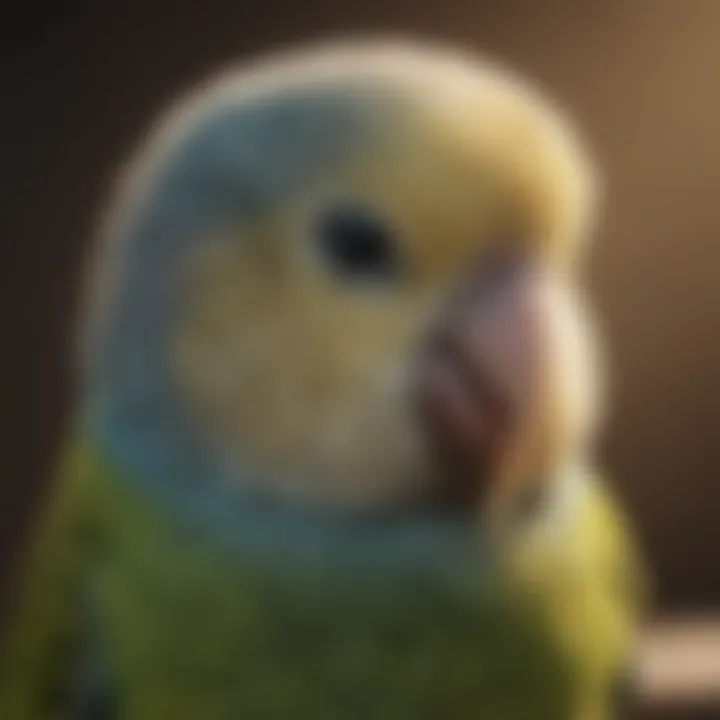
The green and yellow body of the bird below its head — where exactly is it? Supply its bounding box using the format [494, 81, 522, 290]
[0, 434, 637, 720]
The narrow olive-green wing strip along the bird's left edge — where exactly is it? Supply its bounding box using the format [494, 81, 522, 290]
[0, 443, 102, 720]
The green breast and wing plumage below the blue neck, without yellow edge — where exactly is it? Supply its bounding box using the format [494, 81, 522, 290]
[0, 436, 640, 720]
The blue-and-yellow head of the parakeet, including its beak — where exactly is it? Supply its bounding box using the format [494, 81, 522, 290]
[85, 42, 597, 524]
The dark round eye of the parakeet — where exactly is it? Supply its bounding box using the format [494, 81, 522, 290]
[317, 206, 398, 280]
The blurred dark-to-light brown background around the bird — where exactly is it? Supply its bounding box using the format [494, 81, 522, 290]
[0, 0, 720, 632]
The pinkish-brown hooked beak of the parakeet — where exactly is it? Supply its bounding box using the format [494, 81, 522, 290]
[416, 252, 545, 514]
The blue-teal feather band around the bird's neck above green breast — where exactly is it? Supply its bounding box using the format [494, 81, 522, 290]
[87, 400, 484, 570]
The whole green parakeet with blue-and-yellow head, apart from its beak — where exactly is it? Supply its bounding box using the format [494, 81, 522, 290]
[0, 44, 641, 720]
